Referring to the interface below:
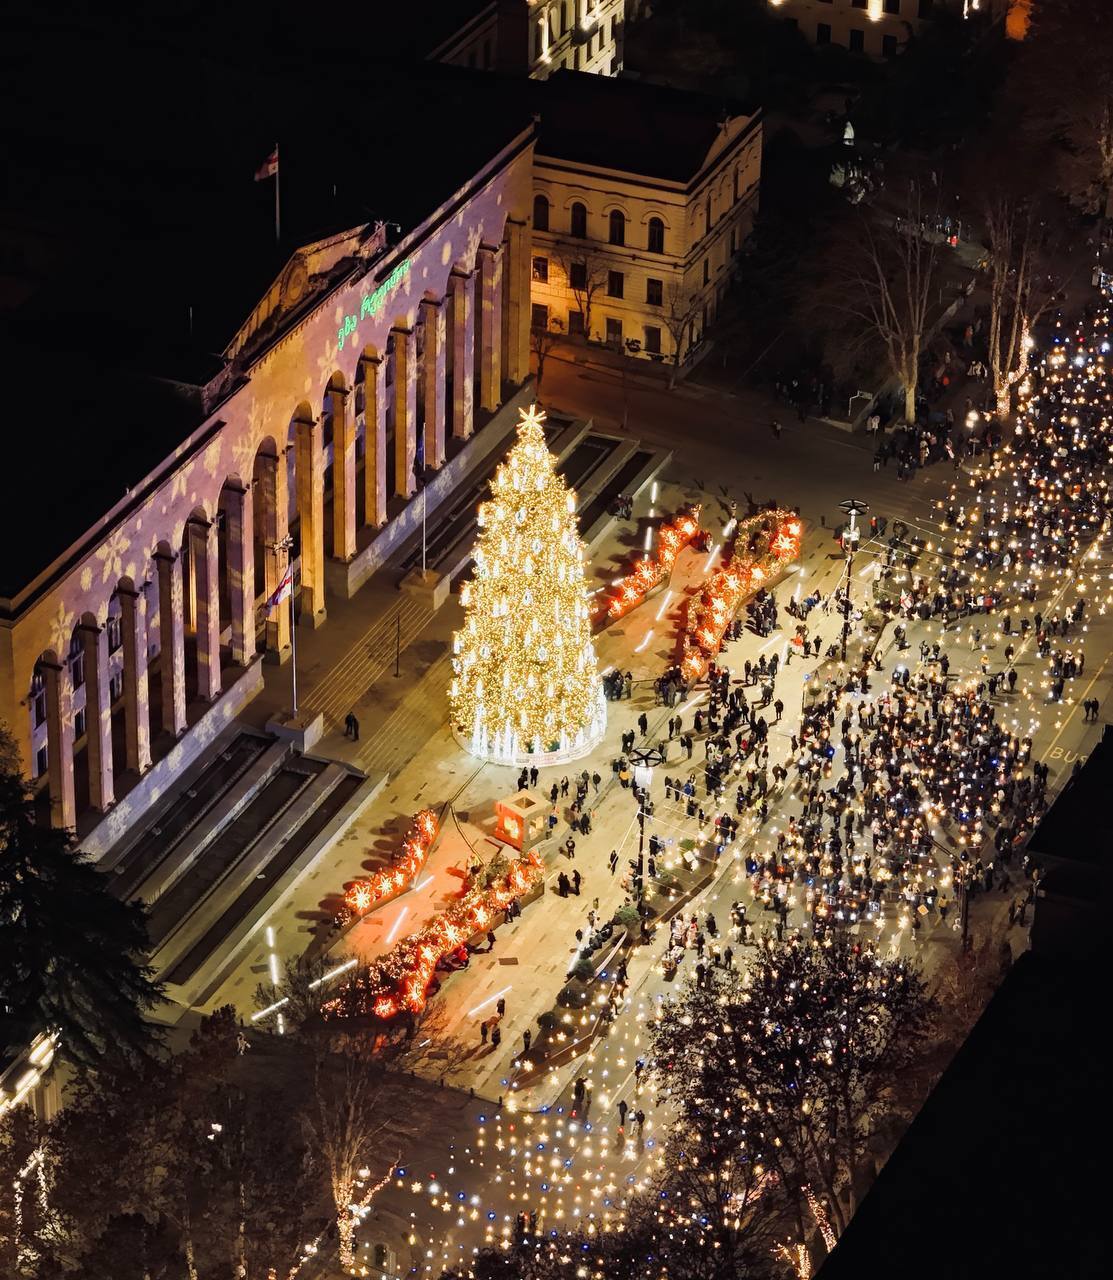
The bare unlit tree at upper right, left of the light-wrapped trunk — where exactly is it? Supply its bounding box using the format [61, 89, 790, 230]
[823, 180, 942, 422]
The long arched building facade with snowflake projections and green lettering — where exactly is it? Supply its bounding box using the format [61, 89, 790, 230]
[0, 135, 532, 845]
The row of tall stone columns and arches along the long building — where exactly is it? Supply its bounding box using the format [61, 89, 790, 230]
[28, 221, 530, 827]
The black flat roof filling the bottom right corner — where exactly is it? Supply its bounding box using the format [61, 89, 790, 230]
[817, 952, 1109, 1280]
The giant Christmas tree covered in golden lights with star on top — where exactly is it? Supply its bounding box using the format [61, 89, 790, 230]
[449, 404, 606, 764]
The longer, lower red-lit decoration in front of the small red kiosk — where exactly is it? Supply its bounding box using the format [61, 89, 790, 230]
[321, 852, 544, 1021]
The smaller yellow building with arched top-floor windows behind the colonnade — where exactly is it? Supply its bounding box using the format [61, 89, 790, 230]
[531, 77, 761, 361]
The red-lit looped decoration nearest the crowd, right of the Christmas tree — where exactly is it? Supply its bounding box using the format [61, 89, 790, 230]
[681, 511, 803, 684]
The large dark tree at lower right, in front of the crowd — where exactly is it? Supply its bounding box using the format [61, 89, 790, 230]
[652, 936, 931, 1269]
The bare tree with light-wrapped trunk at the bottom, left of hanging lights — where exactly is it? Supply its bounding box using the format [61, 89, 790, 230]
[304, 1052, 406, 1271]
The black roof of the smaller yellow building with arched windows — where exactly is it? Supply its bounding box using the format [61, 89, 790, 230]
[527, 70, 746, 184]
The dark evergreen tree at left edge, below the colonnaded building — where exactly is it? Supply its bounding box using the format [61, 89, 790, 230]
[0, 742, 162, 1068]
